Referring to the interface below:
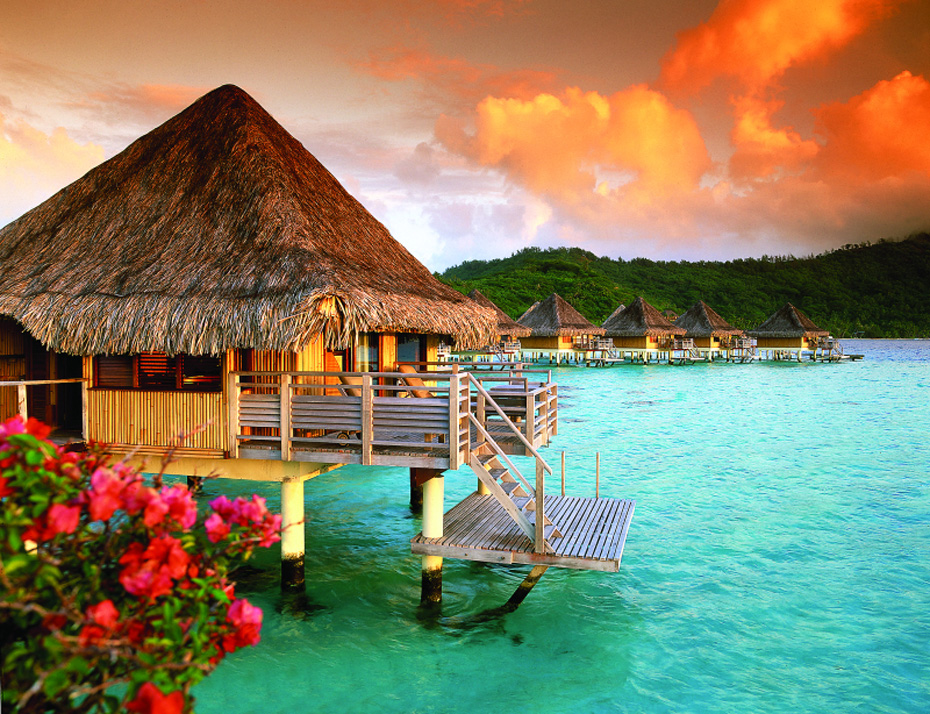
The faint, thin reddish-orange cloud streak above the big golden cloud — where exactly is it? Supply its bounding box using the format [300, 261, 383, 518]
[356, 46, 556, 104]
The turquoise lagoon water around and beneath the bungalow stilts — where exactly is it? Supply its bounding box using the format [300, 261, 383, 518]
[195, 340, 930, 714]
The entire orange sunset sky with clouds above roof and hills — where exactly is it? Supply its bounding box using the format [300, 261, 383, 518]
[0, 0, 930, 269]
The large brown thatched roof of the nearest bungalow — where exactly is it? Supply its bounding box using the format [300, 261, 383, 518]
[0, 85, 497, 354]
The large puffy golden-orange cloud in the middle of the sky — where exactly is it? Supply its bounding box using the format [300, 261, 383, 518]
[436, 85, 710, 206]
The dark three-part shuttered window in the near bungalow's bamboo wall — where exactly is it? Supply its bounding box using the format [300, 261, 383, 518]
[94, 352, 223, 392]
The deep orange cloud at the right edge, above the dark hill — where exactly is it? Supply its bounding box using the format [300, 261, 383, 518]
[815, 72, 930, 181]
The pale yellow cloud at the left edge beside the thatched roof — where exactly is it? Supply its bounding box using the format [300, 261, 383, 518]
[0, 114, 103, 225]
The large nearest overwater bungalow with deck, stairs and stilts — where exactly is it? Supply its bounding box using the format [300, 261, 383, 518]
[0, 86, 632, 602]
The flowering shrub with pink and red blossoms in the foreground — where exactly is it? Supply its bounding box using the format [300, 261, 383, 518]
[0, 417, 281, 714]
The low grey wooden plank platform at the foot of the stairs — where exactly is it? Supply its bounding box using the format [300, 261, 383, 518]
[410, 493, 636, 572]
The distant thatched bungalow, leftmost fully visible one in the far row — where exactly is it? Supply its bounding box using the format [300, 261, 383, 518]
[517, 293, 604, 364]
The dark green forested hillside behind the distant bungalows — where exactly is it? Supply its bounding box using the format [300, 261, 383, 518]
[437, 233, 930, 337]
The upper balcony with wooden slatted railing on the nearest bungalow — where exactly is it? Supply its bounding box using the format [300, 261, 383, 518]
[227, 365, 558, 470]
